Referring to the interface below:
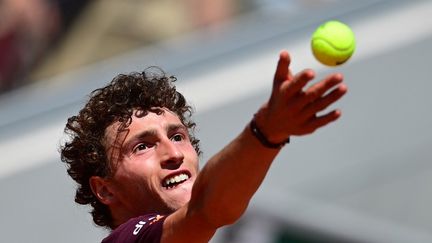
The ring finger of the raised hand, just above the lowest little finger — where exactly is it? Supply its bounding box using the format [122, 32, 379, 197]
[303, 84, 348, 117]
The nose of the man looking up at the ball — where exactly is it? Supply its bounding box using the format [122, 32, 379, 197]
[159, 138, 184, 169]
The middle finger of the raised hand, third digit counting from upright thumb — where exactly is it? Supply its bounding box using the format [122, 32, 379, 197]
[303, 73, 343, 105]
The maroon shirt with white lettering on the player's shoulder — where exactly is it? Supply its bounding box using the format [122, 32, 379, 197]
[102, 214, 166, 243]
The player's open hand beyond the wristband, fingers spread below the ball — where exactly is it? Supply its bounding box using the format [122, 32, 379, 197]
[256, 51, 347, 143]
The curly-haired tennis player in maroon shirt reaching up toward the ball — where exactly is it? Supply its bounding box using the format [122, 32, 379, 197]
[61, 51, 347, 243]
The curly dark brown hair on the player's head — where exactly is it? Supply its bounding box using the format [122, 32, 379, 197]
[60, 67, 200, 228]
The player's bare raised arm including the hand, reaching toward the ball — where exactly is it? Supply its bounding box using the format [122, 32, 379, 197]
[162, 51, 347, 242]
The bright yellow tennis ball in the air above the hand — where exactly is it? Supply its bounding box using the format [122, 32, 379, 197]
[311, 20, 355, 66]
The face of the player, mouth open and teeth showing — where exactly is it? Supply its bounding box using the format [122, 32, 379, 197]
[105, 109, 198, 215]
